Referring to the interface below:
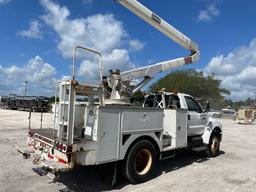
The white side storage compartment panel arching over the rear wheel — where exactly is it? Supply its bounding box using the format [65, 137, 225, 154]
[97, 106, 163, 164]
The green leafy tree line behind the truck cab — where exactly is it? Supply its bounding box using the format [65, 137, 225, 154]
[132, 69, 255, 110]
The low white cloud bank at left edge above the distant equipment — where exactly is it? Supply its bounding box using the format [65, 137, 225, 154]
[0, 56, 56, 96]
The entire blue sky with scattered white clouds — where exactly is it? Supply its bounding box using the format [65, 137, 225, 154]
[0, 0, 256, 100]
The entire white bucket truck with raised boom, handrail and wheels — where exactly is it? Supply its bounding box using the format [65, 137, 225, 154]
[18, 0, 222, 183]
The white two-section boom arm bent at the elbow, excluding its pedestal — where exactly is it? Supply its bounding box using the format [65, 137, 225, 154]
[116, 0, 199, 81]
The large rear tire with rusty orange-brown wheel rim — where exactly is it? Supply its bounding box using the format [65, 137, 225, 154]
[123, 140, 157, 183]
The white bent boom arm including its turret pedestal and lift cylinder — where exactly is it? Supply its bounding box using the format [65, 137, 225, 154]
[104, 0, 200, 100]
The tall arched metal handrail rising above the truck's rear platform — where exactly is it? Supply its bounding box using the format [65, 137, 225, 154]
[72, 45, 103, 82]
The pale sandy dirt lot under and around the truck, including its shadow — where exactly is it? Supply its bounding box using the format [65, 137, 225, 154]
[0, 109, 256, 192]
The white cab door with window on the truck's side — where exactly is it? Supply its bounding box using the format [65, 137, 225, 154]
[185, 96, 207, 136]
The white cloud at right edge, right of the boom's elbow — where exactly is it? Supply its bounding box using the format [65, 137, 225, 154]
[204, 38, 256, 100]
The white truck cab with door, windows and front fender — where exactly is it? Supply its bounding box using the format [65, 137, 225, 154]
[143, 91, 222, 146]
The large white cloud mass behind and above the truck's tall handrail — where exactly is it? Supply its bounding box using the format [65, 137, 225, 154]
[41, 0, 139, 80]
